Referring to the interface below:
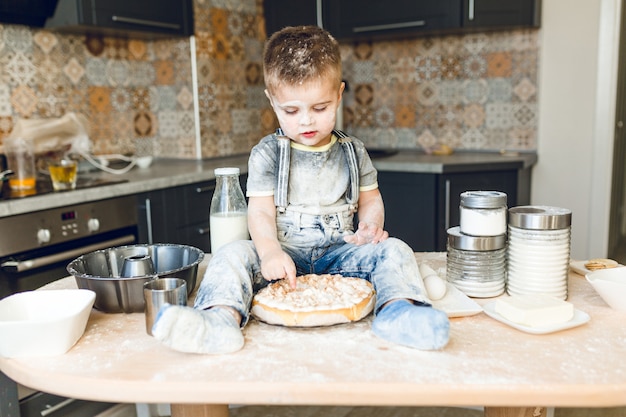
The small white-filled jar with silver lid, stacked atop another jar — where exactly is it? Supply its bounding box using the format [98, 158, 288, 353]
[460, 191, 506, 236]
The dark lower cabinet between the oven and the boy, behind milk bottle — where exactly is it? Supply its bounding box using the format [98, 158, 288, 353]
[137, 175, 247, 253]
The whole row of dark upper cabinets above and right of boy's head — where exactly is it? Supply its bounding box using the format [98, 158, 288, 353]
[263, 0, 541, 41]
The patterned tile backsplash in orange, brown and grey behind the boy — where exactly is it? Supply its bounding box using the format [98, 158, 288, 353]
[0, 0, 539, 158]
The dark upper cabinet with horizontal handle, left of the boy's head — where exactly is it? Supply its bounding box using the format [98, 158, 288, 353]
[46, 0, 194, 38]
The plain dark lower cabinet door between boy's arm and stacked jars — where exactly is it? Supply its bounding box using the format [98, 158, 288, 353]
[378, 172, 437, 252]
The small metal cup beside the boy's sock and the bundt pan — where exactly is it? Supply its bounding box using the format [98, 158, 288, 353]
[143, 278, 187, 336]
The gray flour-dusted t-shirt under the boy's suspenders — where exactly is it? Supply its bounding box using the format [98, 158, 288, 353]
[247, 135, 378, 214]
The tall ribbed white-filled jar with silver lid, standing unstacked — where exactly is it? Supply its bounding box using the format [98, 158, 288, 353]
[507, 206, 572, 300]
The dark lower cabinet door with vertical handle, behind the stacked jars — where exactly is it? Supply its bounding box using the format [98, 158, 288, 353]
[436, 170, 518, 251]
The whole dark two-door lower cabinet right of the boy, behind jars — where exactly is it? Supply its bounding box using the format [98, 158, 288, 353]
[378, 169, 530, 252]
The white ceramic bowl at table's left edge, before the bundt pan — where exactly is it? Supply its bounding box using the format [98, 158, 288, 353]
[0, 290, 96, 357]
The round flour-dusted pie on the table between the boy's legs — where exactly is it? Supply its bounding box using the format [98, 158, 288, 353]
[251, 274, 375, 327]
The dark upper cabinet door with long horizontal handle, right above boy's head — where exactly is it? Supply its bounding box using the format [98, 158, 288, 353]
[322, 0, 461, 39]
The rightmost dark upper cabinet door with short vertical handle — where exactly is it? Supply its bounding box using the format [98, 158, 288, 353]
[462, 0, 541, 29]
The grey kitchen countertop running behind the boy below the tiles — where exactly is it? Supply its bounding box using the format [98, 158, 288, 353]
[0, 150, 537, 217]
